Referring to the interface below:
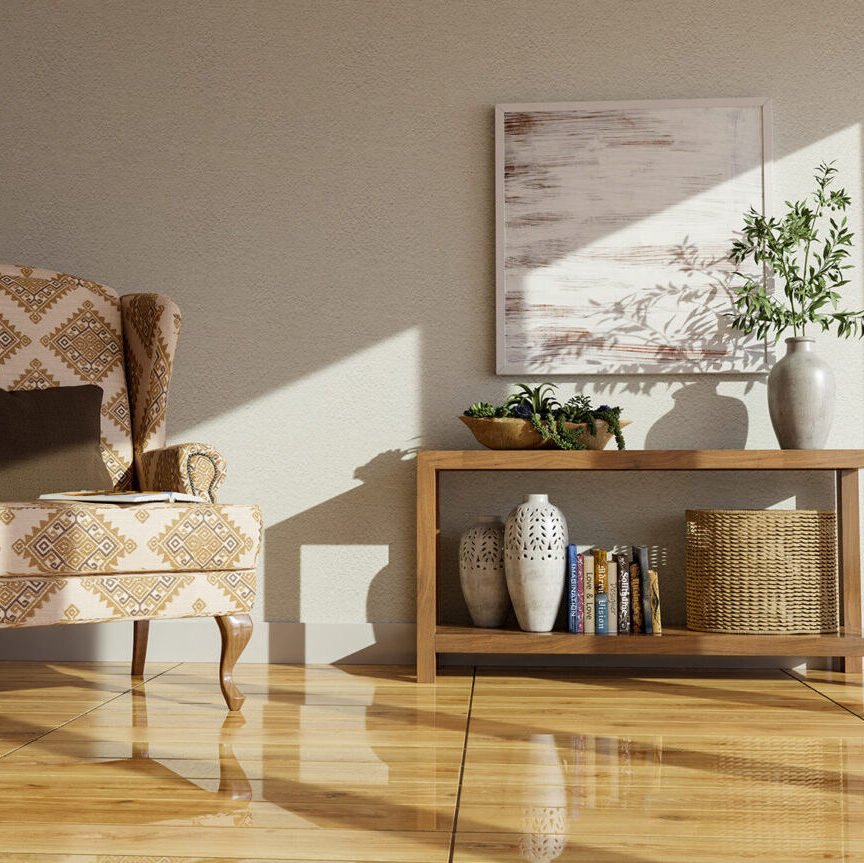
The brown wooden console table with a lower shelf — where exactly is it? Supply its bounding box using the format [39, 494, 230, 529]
[417, 450, 864, 683]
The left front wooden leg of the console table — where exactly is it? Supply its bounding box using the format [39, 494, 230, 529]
[417, 453, 438, 683]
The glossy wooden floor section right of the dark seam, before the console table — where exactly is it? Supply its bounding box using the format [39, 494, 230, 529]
[454, 672, 864, 863]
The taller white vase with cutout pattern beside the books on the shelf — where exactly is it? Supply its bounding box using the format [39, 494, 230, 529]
[504, 494, 567, 632]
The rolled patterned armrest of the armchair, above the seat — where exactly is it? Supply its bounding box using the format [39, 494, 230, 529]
[137, 443, 225, 502]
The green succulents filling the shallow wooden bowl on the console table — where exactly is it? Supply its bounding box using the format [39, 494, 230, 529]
[465, 383, 624, 449]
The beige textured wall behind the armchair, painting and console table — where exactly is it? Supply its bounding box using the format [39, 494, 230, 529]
[0, 0, 864, 660]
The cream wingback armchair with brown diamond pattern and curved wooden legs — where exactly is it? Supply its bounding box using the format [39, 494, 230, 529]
[0, 266, 261, 710]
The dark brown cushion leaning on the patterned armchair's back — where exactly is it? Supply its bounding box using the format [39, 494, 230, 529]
[0, 384, 113, 500]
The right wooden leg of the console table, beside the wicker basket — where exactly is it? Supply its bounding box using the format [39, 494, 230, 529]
[837, 470, 862, 674]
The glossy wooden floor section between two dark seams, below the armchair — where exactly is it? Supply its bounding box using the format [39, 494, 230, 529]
[0, 667, 471, 863]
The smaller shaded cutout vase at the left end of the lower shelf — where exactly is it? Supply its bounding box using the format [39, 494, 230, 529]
[459, 515, 510, 626]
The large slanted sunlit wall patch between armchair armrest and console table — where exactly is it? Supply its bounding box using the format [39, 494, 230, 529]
[169, 328, 421, 524]
